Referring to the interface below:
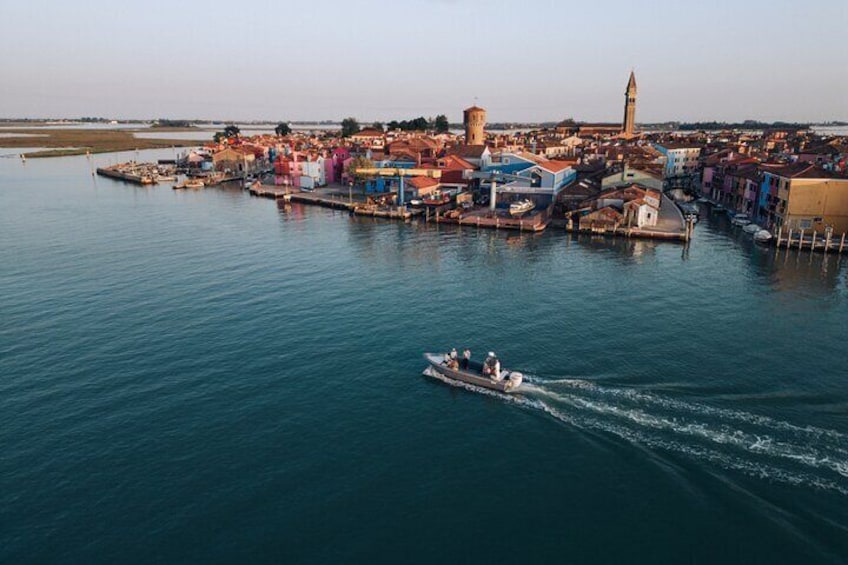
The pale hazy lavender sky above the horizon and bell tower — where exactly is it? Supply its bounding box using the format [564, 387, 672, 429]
[0, 0, 848, 123]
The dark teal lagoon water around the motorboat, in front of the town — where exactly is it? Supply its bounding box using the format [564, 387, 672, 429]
[0, 150, 848, 563]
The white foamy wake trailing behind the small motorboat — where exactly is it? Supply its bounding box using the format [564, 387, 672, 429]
[425, 369, 848, 495]
